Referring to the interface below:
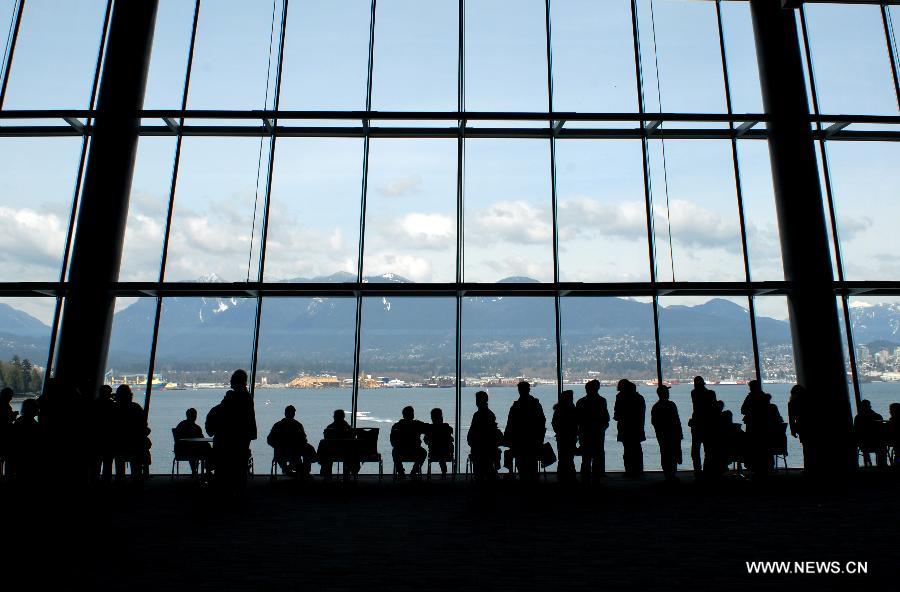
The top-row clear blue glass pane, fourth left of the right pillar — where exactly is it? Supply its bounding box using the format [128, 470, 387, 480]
[465, 0, 548, 111]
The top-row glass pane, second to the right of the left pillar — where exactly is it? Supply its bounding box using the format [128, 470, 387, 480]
[188, 0, 279, 109]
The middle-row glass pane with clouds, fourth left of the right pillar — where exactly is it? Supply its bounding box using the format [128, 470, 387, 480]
[465, 139, 553, 282]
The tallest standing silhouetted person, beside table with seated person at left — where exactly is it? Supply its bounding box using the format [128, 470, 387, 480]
[206, 370, 256, 491]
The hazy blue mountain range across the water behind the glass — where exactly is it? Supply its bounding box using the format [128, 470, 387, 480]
[0, 274, 900, 372]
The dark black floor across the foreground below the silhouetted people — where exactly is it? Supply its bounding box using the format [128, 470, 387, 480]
[0, 473, 900, 591]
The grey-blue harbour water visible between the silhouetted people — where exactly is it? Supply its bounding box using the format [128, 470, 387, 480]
[142, 383, 900, 474]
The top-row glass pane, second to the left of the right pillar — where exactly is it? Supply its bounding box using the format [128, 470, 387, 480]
[638, 0, 726, 116]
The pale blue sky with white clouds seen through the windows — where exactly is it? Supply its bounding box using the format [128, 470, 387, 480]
[0, 0, 900, 328]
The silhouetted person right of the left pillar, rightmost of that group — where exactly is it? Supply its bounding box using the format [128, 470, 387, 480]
[112, 384, 150, 479]
